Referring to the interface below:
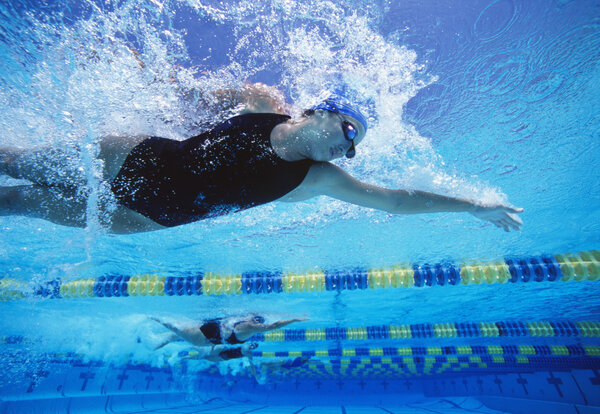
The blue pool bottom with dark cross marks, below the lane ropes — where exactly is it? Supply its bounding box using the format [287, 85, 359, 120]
[0, 363, 600, 414]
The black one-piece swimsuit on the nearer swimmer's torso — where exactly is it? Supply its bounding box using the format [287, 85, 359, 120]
[111, 114, 312, 227]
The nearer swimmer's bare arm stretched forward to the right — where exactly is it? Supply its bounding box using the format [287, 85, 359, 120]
[290, 162, 523, 231]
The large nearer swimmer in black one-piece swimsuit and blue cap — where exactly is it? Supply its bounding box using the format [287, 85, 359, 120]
[0, 85, 523, 233]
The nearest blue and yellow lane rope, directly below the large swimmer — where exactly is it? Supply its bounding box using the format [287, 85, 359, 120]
[0, 250, 600, 300]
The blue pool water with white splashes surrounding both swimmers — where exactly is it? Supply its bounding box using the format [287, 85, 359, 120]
[0, 0, 600, 413]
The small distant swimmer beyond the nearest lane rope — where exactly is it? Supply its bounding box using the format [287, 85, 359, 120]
[150, 314, 308, 349]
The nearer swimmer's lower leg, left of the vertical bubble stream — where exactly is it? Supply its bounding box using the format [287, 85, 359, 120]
[0, 185, 86, 227]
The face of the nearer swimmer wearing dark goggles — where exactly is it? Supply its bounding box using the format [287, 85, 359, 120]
[306, 109, 365, 161]
